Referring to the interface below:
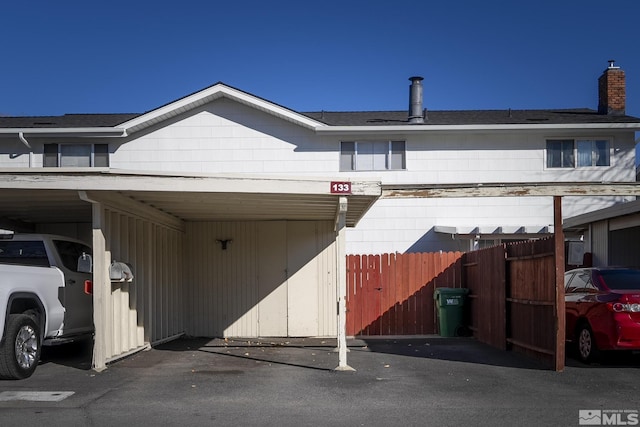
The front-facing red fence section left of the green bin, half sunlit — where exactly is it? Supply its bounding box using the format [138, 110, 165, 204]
[347, 252, 462, 335]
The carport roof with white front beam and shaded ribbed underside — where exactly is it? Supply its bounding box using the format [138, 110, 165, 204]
[0, 168, 381, 231]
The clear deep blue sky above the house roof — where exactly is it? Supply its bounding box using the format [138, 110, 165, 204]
[0, 0, 640, 117]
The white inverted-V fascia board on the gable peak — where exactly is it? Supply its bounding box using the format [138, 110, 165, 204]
[120, 83, 326, 133]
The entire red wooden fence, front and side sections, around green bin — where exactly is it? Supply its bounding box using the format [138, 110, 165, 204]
[347, 232, 565, 371]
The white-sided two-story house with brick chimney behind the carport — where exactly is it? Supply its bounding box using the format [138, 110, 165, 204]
[5, 63, 640, 253]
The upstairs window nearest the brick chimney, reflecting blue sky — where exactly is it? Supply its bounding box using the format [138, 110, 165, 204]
[547, 138, 611, 168]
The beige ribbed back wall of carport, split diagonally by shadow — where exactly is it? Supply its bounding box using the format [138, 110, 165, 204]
[185, 221, 337, 337]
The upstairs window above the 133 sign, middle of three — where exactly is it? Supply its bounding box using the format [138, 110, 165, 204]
[340, 141, 406, 171]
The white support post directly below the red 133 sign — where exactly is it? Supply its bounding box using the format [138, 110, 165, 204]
[335, 197, 355, 371]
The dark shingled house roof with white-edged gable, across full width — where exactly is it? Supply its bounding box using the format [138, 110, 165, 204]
[0, 82, 640, 136]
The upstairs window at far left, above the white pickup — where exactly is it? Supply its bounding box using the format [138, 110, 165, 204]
[43, 144, 109, 168]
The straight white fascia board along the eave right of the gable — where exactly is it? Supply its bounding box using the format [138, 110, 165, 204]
[316, 123, 640, 134]
